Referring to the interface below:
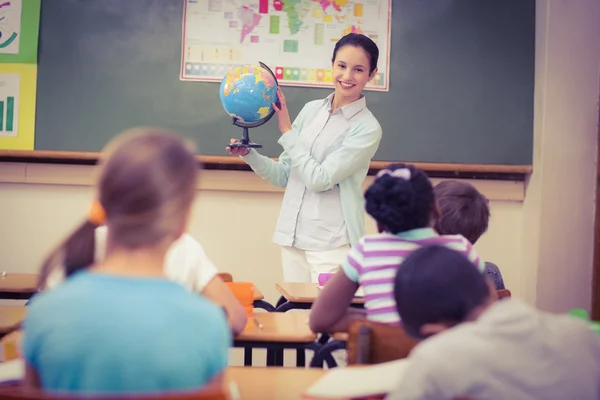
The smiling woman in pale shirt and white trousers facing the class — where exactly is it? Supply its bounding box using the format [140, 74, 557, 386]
[227, 33, 381, 282]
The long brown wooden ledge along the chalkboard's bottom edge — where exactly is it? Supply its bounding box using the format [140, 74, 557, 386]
[0, 150, 533, 181]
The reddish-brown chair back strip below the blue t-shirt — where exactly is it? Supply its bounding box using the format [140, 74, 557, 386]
[0, 386, 230, 400]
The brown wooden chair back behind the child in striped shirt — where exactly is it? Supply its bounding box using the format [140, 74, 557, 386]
[346, 320, 418, 365]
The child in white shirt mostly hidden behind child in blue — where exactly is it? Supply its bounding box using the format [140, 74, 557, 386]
[40, 226, 248, 334]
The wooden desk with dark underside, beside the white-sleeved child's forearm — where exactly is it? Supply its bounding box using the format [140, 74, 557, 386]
[233, 312, 320, 367]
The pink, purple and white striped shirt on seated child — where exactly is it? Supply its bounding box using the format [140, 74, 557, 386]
[342, 228, 485, 325]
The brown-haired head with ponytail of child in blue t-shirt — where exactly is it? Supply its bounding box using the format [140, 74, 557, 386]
[41, 128, 199, 284]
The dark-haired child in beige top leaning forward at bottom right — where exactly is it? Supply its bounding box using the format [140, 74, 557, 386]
[387, 246, 600, 400]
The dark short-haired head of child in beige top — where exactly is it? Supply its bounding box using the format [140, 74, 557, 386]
[394, 246, 496, 338]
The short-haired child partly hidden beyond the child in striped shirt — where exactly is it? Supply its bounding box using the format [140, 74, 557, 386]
[433, 180, 506, 290]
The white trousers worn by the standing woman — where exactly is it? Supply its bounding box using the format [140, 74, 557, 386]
[281, 245, 350, 283]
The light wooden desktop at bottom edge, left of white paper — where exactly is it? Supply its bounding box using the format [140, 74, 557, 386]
[225, 367, 327, 400]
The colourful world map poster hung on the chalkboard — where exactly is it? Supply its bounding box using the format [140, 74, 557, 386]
[180, 0, 392, 91]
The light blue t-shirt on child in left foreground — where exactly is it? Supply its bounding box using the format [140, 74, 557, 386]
[23, 272, 232, 393]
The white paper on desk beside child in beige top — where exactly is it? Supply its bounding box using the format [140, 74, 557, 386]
[305, 359, 408, 399]
